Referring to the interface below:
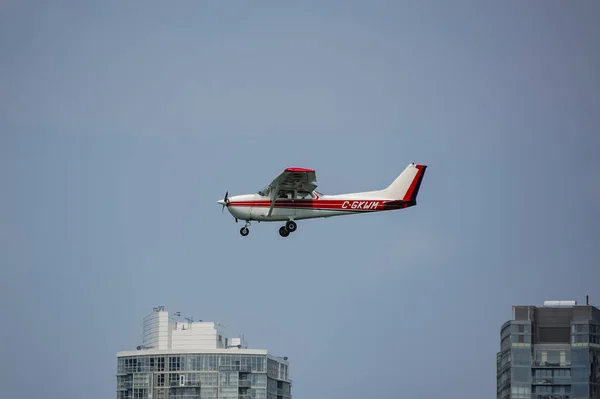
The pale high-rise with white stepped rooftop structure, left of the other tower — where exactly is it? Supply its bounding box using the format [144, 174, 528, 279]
[117, 306, 292, 399]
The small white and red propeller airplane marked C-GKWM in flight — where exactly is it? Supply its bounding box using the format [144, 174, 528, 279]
[217, 162, 427, 237]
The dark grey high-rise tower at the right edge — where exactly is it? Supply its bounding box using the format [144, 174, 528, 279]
[496, 299, 600, 399]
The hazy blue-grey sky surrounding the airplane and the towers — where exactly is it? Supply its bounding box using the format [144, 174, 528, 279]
[0, 0, 600, 399]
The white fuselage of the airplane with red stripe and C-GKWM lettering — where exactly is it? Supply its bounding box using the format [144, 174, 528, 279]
[226, 192, 414, 222]
